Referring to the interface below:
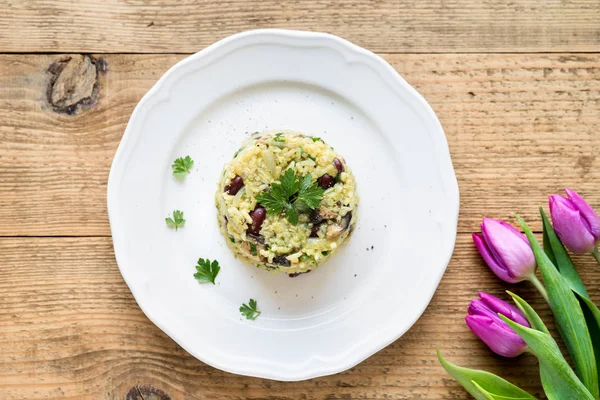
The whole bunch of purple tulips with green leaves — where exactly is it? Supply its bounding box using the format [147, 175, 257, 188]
[438, 189, 600, 400]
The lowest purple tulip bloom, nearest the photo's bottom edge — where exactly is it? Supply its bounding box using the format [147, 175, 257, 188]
[465, 292, 529, 357]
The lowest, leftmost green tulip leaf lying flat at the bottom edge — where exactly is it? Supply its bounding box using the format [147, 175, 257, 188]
[437, 350, 535, 400]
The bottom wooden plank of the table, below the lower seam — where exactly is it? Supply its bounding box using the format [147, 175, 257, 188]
[0, 234, 600, 400]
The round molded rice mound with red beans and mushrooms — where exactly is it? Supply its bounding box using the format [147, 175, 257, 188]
[216, 131, 358, 276]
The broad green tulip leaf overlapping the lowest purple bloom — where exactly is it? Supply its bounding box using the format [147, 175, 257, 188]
[500, 315, 594, 400]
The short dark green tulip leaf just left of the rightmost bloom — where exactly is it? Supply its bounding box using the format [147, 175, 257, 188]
[540, 207, 590, 299]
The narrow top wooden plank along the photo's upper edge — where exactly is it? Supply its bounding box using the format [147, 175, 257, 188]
[0, 0, 600, 53]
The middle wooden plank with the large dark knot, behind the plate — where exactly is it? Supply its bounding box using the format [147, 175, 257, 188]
[0, 54, 600, 236]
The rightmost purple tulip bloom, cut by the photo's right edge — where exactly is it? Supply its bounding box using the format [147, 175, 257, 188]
[549, 189, 600, 254]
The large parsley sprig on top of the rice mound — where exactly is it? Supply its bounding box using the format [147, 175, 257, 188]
[256, 168, 325, 225]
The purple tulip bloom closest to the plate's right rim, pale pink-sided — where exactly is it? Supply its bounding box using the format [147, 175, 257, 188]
[473, 218, 536, 283]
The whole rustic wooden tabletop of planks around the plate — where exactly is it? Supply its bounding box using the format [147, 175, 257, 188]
[0, 0, 600, 400]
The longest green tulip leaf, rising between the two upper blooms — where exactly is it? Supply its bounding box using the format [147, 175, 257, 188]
[516, 216, 600, 398]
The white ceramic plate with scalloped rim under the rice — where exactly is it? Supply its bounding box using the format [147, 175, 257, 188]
[108, 30, 459, 381]
